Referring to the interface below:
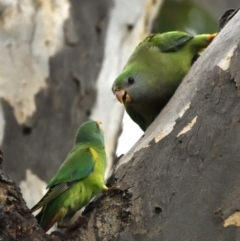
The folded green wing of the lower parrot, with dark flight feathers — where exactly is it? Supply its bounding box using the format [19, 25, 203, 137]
[31, 144, 95, 212]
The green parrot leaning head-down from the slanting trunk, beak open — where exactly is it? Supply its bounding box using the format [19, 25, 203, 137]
[112, 31, 217, 131]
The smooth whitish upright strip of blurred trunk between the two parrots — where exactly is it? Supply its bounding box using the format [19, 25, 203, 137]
[90, 0, 163, 177]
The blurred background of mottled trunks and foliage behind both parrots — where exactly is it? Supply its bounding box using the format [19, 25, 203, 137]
[0, 0, 239, 217]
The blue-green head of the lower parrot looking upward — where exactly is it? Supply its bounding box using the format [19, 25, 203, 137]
[75, 120, 105, 147]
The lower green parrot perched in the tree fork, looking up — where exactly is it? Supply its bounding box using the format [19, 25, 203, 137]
[31, 121, 108, 232]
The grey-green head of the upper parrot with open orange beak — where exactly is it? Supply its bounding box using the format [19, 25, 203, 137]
[112, 65, 149, 106]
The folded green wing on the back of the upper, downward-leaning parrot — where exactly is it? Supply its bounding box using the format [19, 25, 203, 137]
[143, 32, 193, 52]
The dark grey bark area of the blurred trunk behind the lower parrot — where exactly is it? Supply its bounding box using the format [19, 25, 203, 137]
[2, 0, 111, 182]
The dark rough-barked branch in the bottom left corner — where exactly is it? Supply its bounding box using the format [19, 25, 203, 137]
[0, 151, 48, 241]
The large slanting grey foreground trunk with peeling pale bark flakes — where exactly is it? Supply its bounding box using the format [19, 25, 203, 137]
[0, 4, 240, 241]
